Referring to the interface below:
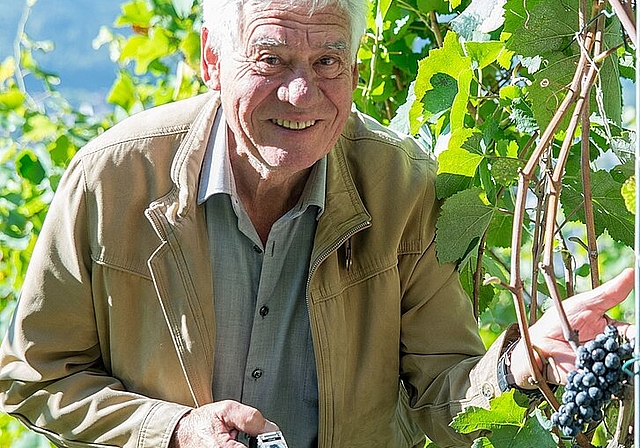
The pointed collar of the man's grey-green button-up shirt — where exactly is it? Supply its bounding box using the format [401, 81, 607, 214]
[198, 107, 327, 218]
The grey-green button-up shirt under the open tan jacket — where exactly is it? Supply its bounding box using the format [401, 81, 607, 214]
[199, 109, 326, 448]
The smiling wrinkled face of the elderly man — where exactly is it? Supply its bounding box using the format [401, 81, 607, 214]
[203, 0, 357, 177]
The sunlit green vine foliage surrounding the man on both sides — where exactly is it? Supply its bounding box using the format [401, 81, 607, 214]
[0, 0, 636, 448]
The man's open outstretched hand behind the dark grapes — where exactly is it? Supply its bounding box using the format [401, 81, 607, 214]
[511, 269, 635, 389]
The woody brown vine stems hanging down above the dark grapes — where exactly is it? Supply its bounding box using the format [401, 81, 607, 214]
[496, 0, 636, 448]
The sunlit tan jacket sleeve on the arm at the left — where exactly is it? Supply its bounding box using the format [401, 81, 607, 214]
[0, 159, 189, 447]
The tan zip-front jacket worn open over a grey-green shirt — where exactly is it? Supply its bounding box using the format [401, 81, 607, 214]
[0, 94, 512, 448]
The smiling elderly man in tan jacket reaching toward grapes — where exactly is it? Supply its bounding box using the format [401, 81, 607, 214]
[0, 0, 633, 448]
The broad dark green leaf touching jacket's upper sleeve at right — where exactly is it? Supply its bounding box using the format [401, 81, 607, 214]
[436, 188, 494, 263]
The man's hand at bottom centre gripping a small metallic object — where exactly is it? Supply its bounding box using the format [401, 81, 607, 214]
[169, 400, 278, 448]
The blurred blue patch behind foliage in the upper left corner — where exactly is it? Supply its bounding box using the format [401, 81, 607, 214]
[0, 0, 124, 108]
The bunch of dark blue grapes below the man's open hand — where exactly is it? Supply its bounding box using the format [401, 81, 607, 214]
[551, 325, 633, 437]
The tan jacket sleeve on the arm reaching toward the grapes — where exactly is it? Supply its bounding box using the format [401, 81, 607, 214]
[400, 160, 517, 447]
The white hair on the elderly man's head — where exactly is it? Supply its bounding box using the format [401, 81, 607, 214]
[202, 0, 369, 61]
